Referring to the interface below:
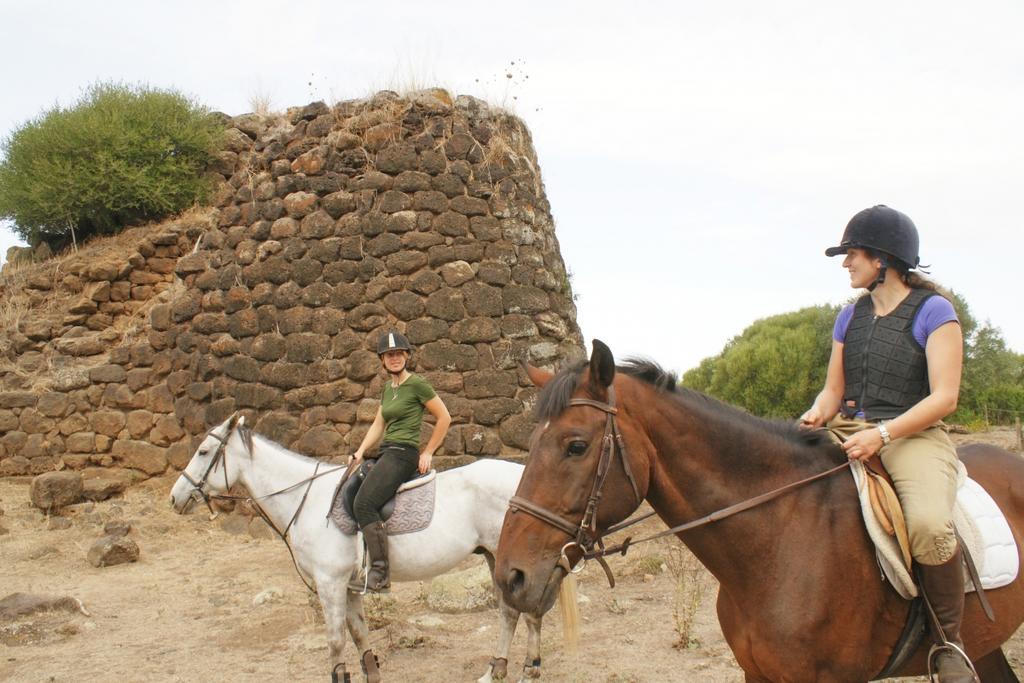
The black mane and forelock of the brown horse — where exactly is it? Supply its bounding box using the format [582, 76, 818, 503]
[536, 358, 831, 456]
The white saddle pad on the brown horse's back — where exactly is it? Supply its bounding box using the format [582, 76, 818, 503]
[850, 461, 1020, 600]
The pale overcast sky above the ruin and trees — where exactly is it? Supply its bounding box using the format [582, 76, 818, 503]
[0, 0, 1024, 372]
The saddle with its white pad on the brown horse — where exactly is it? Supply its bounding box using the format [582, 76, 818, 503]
[850, 459, 1019, 600]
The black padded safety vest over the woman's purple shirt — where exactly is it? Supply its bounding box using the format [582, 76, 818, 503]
[842, 289, 935, 421]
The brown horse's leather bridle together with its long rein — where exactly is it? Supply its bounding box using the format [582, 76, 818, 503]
[509, 387, 850, 588]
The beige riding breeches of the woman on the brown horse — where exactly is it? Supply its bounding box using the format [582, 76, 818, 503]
[827, 415, 957, 564]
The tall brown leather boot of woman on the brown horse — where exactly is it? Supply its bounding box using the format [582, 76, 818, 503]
[918, 546, 978, 683]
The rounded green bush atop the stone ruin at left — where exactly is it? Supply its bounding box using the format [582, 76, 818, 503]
[0, 83, 223, 248]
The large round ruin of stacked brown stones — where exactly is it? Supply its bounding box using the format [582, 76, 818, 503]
[0, 90, 582, 488]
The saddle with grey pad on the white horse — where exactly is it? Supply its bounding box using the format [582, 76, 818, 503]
[328, 460, 437, 536]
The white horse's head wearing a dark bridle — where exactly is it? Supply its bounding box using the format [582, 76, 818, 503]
[171, 413, 249, 514]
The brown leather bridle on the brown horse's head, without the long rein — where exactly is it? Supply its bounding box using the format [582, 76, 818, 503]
[509, 387, 653, 586]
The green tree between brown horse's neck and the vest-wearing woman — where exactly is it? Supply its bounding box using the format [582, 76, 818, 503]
[682, 305, 839, 418]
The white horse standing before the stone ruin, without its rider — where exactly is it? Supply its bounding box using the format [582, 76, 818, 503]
[171, 415, 557, 683]
